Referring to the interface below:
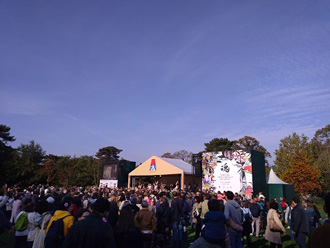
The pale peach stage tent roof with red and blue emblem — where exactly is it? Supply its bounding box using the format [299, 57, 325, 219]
[129, 156, 193, 176]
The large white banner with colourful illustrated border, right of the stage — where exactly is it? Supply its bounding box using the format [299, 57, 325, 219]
[202, 150, 253, 198]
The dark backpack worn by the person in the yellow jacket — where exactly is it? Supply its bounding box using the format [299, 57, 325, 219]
[45, 215, 70, 248]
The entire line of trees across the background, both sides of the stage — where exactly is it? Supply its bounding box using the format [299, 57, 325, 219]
[0, 125, 330, 194]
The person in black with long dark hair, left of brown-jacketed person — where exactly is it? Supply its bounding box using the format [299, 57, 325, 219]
[115, 206, 143, 248]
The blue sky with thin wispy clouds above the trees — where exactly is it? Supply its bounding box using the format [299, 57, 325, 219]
[0, 0, 330, 166]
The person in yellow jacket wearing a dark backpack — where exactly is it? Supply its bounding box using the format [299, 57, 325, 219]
[45, 199, 74, 248]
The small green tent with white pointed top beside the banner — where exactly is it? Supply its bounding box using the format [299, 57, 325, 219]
[267, 169, 294, 202]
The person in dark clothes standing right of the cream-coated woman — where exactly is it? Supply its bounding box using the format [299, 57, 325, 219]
[290, 196, 309, 248]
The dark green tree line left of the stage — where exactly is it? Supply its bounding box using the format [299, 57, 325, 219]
[0, 125, 122, 186]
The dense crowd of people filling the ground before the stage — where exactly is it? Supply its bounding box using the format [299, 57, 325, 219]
[0, 183, 330, 248]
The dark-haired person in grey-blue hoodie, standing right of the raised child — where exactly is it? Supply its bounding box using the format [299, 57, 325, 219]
[225, 191, 243, 248]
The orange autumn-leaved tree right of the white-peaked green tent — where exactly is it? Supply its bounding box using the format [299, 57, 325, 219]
[283, 149, 321, 195]
